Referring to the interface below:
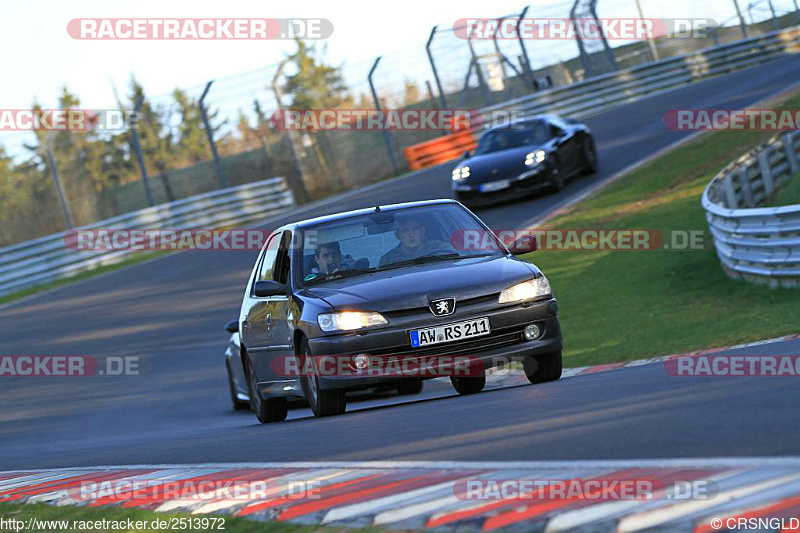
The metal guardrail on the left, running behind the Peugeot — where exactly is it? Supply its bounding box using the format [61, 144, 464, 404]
[0, 178, 295, 296]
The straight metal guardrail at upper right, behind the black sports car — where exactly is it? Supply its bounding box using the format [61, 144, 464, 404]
[481, 26, 800, 127]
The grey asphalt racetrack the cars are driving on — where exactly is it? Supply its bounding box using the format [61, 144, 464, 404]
[0, 56, 800, 470]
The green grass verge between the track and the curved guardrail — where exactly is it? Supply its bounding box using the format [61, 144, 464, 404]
[525, 93, 800, 366]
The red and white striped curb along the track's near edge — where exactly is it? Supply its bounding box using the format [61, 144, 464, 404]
[0, 457, 800, 532]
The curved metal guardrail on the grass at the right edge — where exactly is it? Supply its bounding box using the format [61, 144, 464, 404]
[703, 132, 800, 287]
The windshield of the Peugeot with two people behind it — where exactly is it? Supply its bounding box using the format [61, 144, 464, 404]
[301, 204, 506, 284]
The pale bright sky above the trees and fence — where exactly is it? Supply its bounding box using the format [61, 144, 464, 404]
[0, 0, 792, 156]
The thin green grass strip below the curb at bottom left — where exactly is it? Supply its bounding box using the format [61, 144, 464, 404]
[0, 503, 380, 533]
